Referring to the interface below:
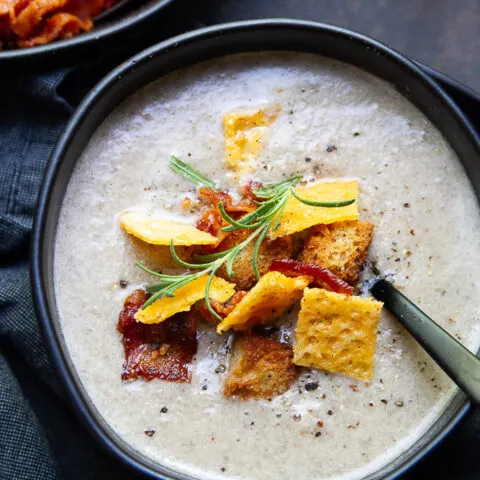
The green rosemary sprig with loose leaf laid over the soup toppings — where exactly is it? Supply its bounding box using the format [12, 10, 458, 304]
[137, 157, 355, 321]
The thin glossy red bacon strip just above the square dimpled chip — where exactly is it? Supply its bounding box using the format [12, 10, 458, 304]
[270, 259, 353, 295]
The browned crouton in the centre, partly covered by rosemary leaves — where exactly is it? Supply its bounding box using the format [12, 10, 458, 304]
[215, 229, 294, 290]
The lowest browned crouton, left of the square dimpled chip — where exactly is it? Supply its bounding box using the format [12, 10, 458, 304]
[223, 335, 298, 399]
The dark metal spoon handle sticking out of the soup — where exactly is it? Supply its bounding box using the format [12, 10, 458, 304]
[370, 279, 480, 404]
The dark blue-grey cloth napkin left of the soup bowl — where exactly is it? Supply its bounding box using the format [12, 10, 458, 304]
[0, 71, 139, 480]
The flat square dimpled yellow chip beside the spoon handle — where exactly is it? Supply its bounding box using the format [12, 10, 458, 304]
[293, 288, 383, 381]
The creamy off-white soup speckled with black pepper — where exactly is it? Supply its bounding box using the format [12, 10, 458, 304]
[55, 53, 480, 479]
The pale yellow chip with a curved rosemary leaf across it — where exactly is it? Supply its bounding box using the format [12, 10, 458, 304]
[270, 180, 358, 238]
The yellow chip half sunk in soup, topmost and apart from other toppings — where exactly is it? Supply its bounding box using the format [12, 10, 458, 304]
[223, 105, 281, 170]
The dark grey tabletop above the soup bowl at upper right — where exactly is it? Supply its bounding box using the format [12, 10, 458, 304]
[185, 0, 480, 90]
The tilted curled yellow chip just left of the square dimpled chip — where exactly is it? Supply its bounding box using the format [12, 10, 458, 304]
[217, 272, 308, 333]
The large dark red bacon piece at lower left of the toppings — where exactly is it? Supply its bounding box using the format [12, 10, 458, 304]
[117, 290, 197, 383]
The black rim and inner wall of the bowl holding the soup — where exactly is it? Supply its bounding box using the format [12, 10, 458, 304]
[31, 20, 480, 479]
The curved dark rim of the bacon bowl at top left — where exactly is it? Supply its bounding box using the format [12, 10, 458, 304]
[0, 0, 173, 72]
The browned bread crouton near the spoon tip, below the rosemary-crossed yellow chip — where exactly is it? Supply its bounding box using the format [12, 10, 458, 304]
[299, 220, 373, 285]
